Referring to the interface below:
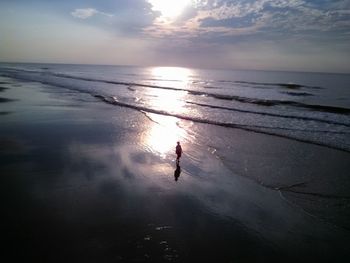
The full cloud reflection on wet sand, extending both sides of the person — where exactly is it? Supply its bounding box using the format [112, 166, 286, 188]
[65, 144, 336, 245]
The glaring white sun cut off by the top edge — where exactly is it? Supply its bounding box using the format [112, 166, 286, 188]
[148, 0, 190, 18]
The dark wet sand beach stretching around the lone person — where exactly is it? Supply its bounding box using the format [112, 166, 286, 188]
[0, 67, 350, 262]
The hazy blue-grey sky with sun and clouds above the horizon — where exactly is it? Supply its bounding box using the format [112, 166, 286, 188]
[0, 0, 350, 73]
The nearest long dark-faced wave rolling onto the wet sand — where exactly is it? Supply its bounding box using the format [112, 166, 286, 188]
[93, 94, 350, 153]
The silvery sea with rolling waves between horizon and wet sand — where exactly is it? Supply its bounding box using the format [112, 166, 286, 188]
[0, 63, 350, 152]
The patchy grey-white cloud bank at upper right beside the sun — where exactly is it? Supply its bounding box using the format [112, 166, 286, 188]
[145, 0, 350, 41]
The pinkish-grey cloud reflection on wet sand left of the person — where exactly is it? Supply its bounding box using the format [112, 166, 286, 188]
[69, 143, 172, 190]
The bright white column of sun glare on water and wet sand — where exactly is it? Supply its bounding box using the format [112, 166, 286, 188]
[144, 67, 192, 158]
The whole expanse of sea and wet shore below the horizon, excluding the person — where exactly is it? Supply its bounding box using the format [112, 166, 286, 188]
[0, 63, 350, 262]
